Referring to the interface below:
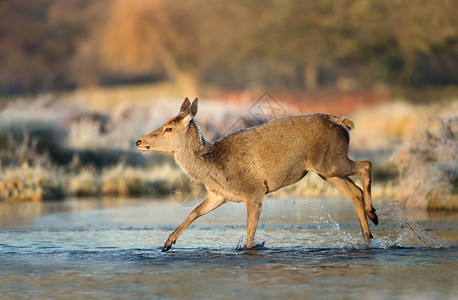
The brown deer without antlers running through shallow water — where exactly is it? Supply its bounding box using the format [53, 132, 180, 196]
[136, 97, 378, 252]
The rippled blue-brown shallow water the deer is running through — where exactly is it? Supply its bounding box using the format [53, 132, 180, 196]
[0, 199, 458, 299]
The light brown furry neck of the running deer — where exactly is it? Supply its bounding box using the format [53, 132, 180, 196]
[174, 119, 211, 180]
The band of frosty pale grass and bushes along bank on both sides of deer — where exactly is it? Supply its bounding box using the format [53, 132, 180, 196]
[0, 91, 458, 209]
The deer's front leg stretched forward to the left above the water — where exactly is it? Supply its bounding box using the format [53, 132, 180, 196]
[162, 192, 224, 252]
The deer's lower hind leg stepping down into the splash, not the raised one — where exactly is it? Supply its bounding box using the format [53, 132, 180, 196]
[323, 177, 372, 241]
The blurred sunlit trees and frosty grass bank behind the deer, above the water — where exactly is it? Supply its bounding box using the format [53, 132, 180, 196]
[0, 0, 458, 210]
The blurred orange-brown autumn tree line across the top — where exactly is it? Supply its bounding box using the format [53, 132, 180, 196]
[0, 0, 458, 94]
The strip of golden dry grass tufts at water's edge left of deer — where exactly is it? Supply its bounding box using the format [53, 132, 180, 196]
[0, 163, 182, 202]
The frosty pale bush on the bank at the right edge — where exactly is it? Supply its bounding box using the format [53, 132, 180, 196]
[394, 109, 458, 210]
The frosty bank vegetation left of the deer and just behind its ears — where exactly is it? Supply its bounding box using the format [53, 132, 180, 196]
[0, 95, 243, 201]
